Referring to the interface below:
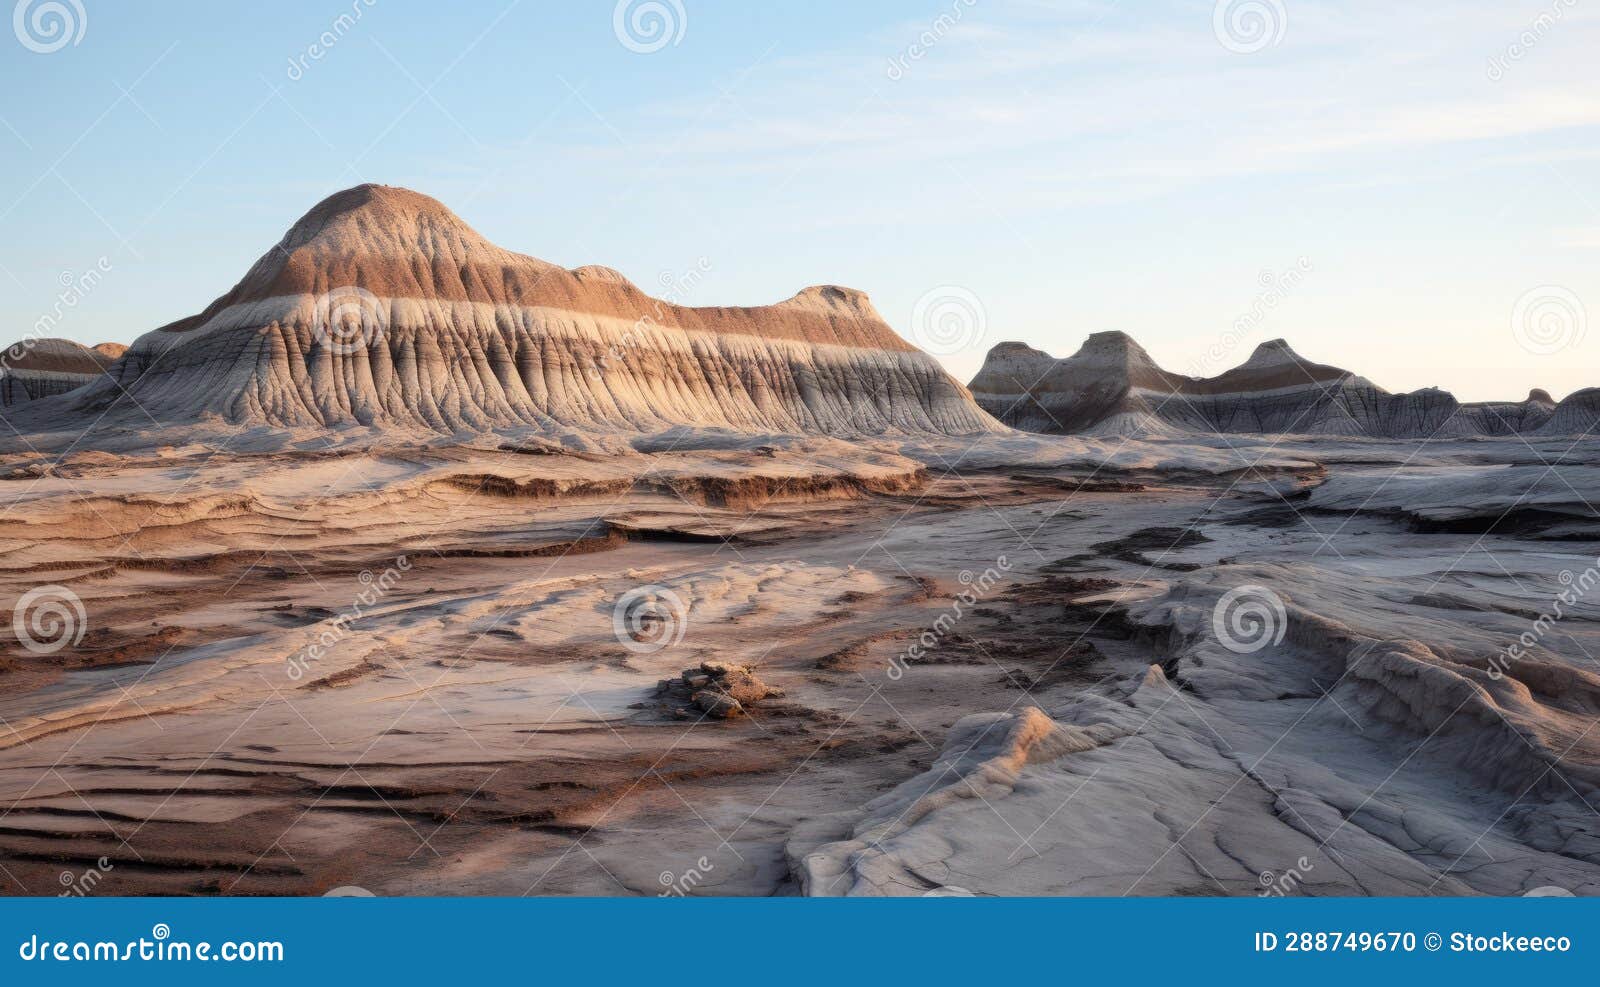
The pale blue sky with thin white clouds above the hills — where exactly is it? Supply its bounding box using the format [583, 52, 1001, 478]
[0, 0, 1600, 400]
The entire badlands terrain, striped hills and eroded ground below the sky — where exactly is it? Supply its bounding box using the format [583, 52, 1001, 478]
[0, 186, 1600, 896]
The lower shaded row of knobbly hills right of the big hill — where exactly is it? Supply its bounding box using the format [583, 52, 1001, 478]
[970, 333, 1580, 438]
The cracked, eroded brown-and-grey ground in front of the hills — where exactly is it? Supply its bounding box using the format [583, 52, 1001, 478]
[0, 438, 1600, 894]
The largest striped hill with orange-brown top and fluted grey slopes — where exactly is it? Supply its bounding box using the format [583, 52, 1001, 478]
[37, 186, 1000, 435]
